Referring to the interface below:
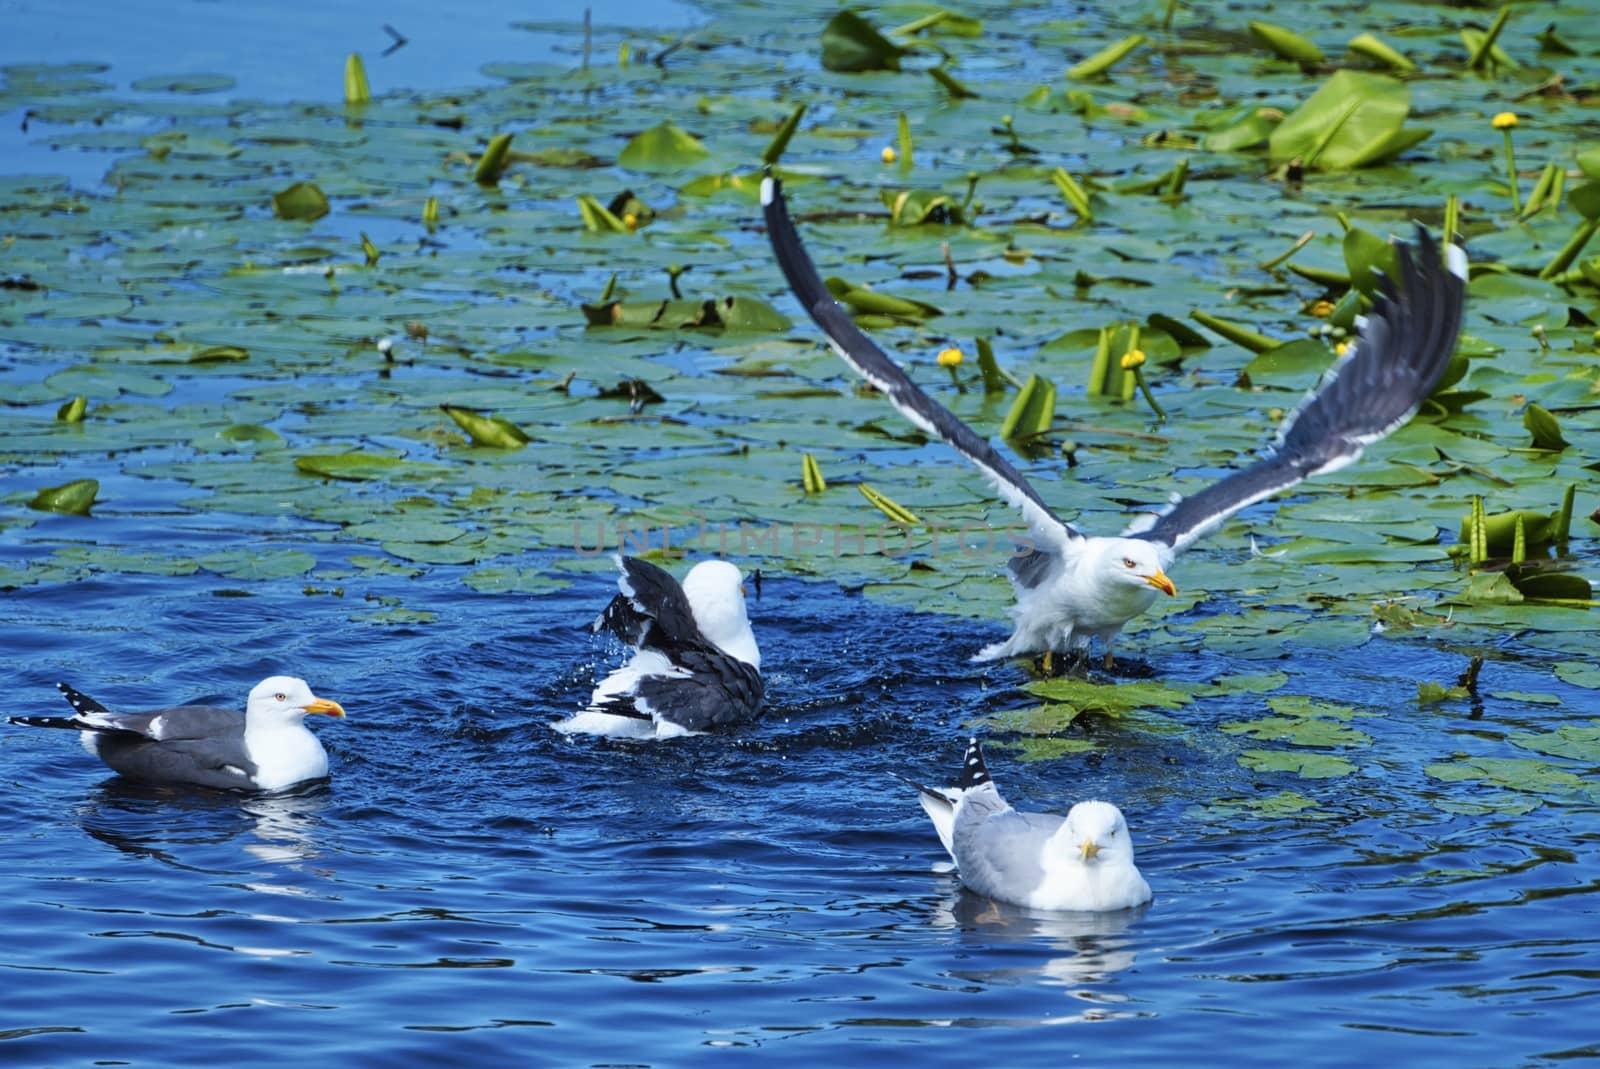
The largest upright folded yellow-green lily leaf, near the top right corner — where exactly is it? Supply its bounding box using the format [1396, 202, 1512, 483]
[1267, 70, 1432, 171]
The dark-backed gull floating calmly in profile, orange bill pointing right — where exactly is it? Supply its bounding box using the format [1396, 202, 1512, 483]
[11, 675, 344, 791]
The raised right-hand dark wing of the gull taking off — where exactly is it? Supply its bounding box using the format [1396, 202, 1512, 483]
[1128, 226, 1467, 551]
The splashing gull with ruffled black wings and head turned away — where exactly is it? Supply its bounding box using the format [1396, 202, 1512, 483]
[554, 555, 765, 739]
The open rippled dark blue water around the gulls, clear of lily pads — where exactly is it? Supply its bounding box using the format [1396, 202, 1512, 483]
[0, 5, 1600, 1069]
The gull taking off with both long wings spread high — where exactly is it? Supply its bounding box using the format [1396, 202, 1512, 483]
[762, 174, 1467, 667]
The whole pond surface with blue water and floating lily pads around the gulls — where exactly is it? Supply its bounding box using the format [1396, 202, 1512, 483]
[0, 5, 1600, 1067]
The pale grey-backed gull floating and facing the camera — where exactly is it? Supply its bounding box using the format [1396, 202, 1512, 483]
[907, 738, 1150, 912]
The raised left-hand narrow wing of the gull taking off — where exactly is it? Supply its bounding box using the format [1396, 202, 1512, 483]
[762, 174, 1082, 552]
